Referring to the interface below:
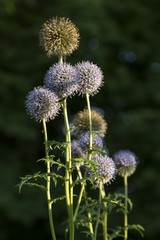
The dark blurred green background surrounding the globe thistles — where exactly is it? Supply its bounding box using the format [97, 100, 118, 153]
[0, 0, 160, 240]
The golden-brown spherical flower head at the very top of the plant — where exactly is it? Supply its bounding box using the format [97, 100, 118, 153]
[40, 17, 79, 56]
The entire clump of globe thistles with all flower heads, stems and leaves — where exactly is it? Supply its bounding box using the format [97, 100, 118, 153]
[19, 17, 141, 240]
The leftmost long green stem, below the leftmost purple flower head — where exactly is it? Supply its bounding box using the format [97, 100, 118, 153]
[43, 119, 56, 240]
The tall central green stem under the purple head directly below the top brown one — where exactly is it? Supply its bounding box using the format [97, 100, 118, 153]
[63, 99, 74, 240]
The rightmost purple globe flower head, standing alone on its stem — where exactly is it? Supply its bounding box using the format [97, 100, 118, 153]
[113, 150, 137, 177]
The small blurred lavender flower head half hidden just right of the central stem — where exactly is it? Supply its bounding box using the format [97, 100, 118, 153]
[71, 140, 85, 167]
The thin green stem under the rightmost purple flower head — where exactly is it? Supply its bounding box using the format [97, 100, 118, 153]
[124, 175, 128, 240]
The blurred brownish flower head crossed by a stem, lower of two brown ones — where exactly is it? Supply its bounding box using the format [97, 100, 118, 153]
[73, 109, 107, 137]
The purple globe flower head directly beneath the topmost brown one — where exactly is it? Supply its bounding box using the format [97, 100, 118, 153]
[44, 63, 78, 98]
